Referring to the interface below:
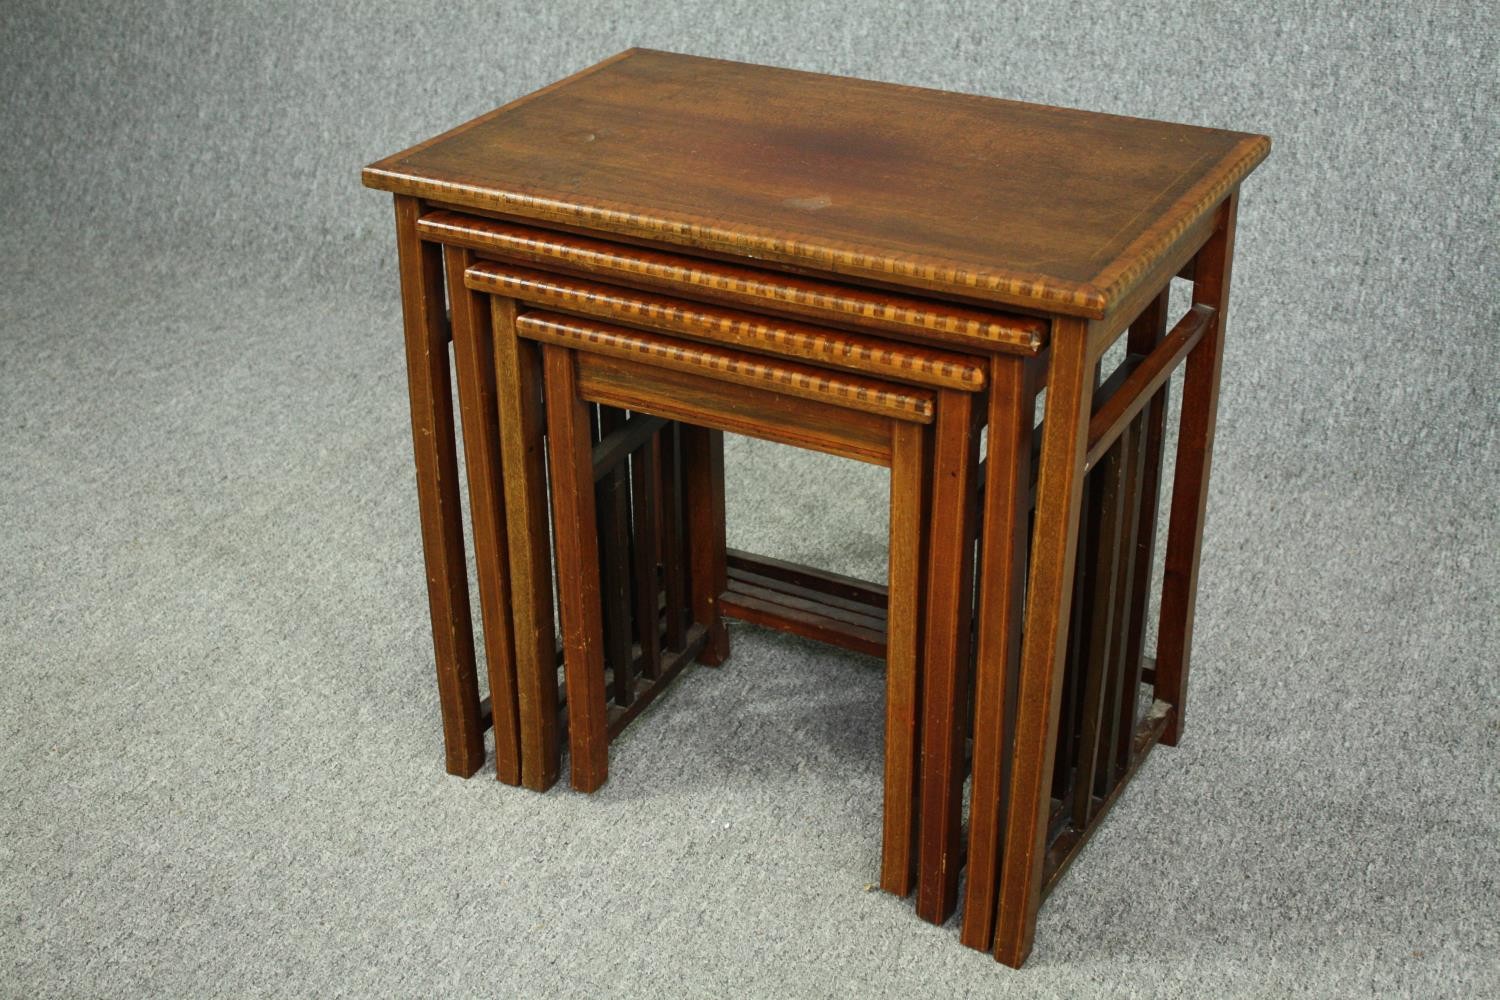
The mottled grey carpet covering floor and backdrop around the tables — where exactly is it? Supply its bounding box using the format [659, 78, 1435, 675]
[0, 0, 1500, 997]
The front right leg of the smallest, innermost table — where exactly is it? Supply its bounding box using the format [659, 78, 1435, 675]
[881, 423, 929, 897]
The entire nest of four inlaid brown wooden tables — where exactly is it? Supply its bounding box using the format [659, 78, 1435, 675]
[365, 49, 1269, 964]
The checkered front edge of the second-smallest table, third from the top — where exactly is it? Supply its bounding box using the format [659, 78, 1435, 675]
[465, 261, 984, 391]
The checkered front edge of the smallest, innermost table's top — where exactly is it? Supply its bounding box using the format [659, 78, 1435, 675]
[516, 312, 933, 424]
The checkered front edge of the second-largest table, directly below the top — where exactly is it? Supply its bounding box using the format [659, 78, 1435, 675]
[417, 211, 1047, 355]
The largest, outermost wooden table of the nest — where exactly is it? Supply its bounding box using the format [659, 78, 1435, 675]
[365, 49, 1271, 966]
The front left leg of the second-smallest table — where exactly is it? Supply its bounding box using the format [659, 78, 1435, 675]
[489, 298, 561, 792]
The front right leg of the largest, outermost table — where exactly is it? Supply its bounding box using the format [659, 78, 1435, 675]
[995, 319, 1094, 967]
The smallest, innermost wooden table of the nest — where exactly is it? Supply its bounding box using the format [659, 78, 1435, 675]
[516, 313, 936, 894]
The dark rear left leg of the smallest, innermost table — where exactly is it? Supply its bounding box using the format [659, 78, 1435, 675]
[681, 424, 729, 666]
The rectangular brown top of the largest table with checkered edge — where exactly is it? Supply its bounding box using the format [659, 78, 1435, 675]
[363, 49, 1271, 318]
